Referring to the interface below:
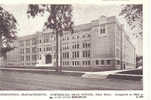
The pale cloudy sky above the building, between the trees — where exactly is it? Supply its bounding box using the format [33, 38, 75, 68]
[2, 4, 142, 53]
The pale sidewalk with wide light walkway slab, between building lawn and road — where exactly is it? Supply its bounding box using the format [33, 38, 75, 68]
[0, 68, 122, 79]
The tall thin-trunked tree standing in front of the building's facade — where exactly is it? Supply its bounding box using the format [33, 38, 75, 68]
[27, 4, 73, 71]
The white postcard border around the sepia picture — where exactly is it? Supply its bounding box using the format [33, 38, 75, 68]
[0, 0, 151, 100]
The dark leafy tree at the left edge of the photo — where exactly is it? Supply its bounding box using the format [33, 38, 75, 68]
[0, 6, 17, 64]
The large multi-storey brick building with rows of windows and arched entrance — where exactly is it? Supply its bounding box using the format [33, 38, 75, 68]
[8, 16, 136, 69]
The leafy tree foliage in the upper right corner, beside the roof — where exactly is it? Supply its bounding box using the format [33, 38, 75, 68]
[119, 4, 143, 37]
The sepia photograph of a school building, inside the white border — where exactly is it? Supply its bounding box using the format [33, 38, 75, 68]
[0, 4, 143, 91]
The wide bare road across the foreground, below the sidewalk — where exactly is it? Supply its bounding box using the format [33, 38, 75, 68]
[0, 70, 143, 90]
